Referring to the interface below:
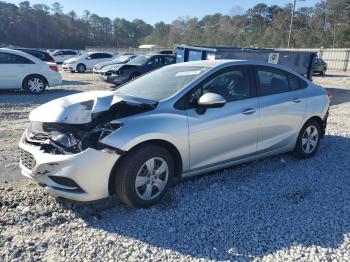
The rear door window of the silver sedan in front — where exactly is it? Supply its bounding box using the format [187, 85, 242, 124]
[257, 67, 289, 96]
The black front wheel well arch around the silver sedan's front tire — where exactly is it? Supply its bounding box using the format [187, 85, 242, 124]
[108, 139, 183, 195]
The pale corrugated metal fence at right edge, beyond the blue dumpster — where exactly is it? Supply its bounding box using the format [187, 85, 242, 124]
[283, 48, 350, 71]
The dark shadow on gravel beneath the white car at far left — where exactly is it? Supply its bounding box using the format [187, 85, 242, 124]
[0, 88, 82, 107]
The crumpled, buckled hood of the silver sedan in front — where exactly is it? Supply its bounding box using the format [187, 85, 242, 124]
[29, 91, 156, 124]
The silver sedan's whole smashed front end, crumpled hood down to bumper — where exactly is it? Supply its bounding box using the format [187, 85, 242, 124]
[19, 92, 156, 201]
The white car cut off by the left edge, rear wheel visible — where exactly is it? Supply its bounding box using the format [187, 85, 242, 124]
[0, 48, 62, 94]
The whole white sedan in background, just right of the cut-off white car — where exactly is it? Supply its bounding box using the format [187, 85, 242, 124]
[62, 52, 115, 73]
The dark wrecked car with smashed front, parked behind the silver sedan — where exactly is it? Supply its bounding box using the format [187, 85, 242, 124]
[100, 54, 176, 85]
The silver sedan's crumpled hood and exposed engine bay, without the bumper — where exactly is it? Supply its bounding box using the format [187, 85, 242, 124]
[24, 92, 156, 154]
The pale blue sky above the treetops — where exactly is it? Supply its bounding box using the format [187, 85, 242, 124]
[4, 0, 319, 25]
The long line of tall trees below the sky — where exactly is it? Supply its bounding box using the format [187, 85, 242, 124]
[0, 0, 350, 48]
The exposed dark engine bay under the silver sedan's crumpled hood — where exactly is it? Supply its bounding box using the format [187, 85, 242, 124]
[24, 95, 156, 154]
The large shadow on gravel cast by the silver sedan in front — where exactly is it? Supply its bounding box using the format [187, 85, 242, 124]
[65, 136, 350, 261]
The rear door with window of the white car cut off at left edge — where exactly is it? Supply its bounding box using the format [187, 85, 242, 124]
[0, 51, 34, 89]
